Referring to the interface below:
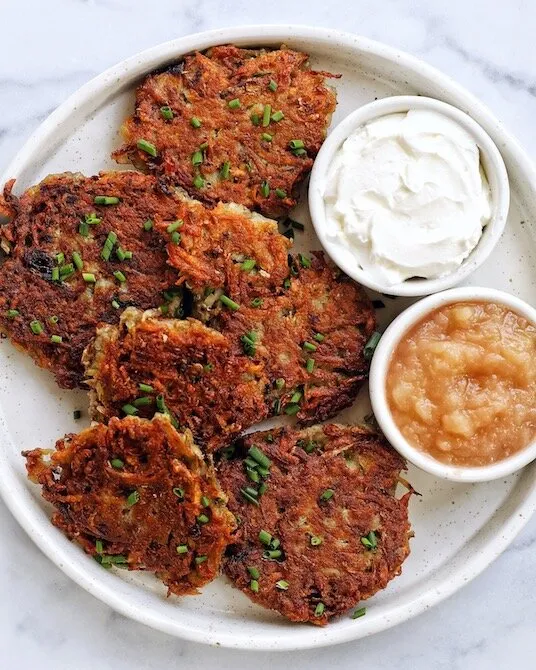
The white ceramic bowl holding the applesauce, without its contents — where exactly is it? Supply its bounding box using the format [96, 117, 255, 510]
[369, 286, 536, 482]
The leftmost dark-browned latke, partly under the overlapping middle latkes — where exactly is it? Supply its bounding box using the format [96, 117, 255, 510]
[0, 172, 182, 388]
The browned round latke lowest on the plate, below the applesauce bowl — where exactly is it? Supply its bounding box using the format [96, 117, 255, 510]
[218, 424, 411, 625]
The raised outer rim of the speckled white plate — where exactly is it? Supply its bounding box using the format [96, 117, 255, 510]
[0, 24, 536, 651]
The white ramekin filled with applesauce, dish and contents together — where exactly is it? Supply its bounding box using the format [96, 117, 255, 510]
[370, 287, 536, 482]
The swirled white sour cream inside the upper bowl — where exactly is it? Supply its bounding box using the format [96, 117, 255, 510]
[324, 110, 491, 285]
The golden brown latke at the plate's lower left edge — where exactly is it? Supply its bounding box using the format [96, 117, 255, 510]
[23, 415, 234, 595]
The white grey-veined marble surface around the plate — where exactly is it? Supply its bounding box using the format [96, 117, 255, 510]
[0, 0, 536, 670]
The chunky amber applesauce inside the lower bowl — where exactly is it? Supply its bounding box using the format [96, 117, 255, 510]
[386, 301, 536, 467]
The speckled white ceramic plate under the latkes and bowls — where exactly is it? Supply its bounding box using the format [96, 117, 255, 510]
[0, 26, 536, 650]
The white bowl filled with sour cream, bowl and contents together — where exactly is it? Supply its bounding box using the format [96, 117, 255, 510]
[309, 96, 510, 296]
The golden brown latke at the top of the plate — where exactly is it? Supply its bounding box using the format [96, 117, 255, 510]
[114, 45, 336, 217]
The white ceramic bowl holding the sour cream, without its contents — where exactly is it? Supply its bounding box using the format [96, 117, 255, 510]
[309, 95, 510, 296]
